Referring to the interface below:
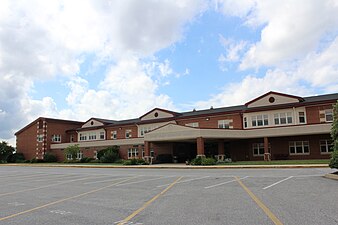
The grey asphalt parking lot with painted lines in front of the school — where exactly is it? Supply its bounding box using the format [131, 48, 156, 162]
[0, 166, 338, 225]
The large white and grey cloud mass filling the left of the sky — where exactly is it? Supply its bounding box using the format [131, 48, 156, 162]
[0, 0, 207, 144]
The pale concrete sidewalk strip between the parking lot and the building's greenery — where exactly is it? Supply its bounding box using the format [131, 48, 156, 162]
[0, 163, 329, 169]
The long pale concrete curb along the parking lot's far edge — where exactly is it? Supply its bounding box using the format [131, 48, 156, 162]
[0, 163, 328, 169]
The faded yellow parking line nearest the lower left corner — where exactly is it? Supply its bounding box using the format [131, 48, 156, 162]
[0, 177, 135, 221]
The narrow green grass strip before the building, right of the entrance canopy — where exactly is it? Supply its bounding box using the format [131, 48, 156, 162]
[219, 159, 330, 165]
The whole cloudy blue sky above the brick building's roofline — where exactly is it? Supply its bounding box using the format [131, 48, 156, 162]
[0, 0, 338, 145]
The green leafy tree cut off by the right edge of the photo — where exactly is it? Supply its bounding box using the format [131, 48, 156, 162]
[329, 101, 338, 169]
